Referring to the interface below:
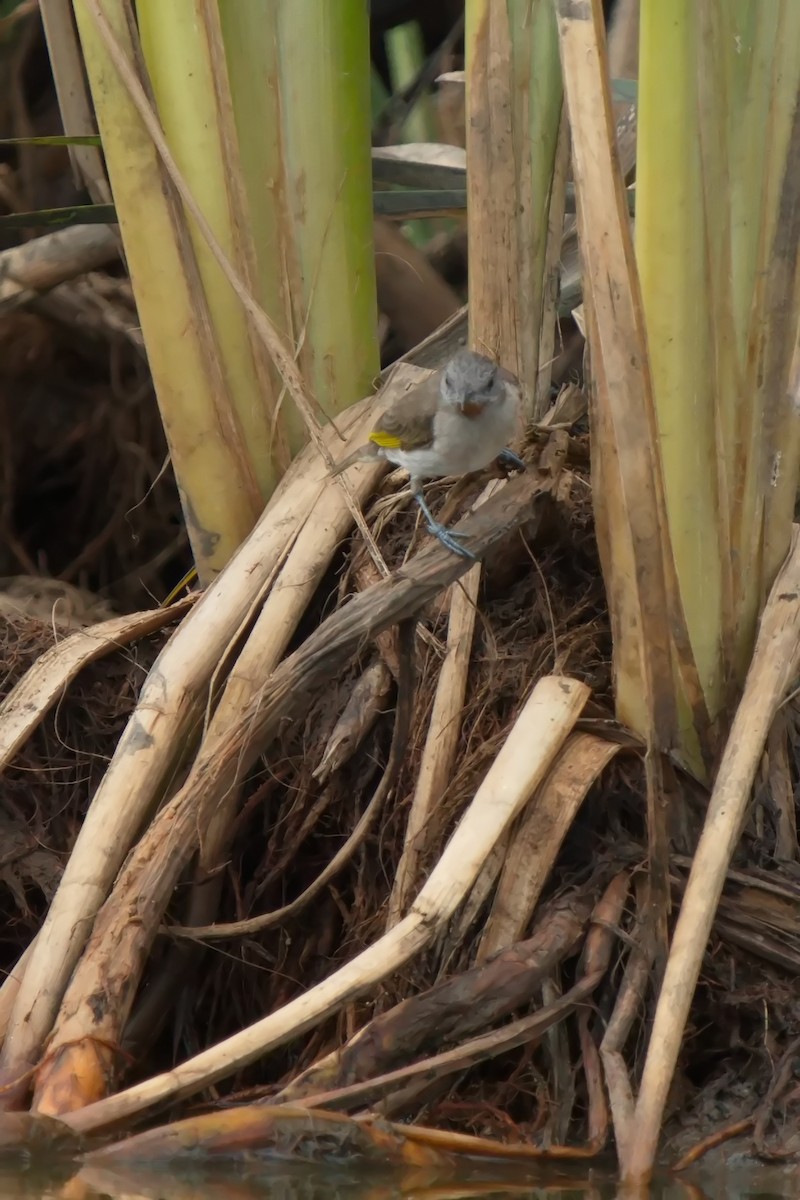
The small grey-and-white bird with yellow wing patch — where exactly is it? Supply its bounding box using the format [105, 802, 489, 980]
[333, 350, 525, 559]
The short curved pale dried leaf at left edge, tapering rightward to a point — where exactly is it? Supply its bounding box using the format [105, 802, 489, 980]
[0, 599, 193, 772]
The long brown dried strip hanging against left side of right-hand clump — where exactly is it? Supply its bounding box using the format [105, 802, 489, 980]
[557, 0, 690, 988]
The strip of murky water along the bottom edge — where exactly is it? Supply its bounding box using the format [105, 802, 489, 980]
[0, 1163, 800, 1200]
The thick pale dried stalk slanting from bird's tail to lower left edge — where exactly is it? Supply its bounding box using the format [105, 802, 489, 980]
[0, 379, 393, 1073]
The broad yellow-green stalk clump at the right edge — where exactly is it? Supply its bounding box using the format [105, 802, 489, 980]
[636, 0, 800, 766]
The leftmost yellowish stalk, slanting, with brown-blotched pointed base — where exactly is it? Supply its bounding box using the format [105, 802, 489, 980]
[74, 0, 263, 581]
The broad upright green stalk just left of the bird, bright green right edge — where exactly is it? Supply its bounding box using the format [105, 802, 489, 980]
[221, 0, 379, 452]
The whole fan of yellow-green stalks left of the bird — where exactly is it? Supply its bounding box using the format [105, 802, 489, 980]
[74, 0, 378, 581]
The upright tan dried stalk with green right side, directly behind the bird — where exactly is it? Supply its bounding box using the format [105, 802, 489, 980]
[464, 0, 563, 416]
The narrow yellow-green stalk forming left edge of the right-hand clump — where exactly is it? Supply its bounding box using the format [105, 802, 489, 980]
[626, 0, 729, 773]
